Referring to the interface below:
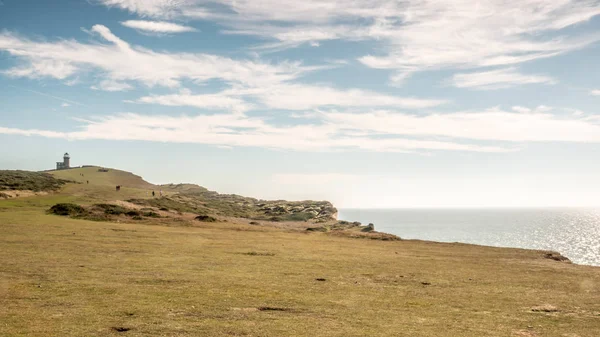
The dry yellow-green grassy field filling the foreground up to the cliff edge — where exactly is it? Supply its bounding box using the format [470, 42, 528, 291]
[0, 170, 600, 337]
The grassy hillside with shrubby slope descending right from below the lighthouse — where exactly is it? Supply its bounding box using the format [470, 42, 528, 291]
[50, 167, 337, 222]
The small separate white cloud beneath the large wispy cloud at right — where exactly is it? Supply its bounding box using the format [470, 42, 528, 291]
[451, 68, 557, 90]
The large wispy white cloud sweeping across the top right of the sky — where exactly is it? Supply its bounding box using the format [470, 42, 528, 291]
[101, 0, 600, 83]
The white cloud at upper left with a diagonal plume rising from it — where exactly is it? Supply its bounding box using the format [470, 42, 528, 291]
[0, 25, 318, 87]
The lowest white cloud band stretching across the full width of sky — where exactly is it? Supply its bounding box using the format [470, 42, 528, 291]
[0, 106, 600, 152]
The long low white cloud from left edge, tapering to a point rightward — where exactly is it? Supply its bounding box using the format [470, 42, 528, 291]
[0, 114, 511, 152]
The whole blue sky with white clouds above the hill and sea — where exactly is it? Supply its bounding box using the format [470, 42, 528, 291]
[0, 0, 600, 208]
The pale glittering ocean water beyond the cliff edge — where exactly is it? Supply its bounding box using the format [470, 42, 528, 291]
[338, 208, 600, 266]
